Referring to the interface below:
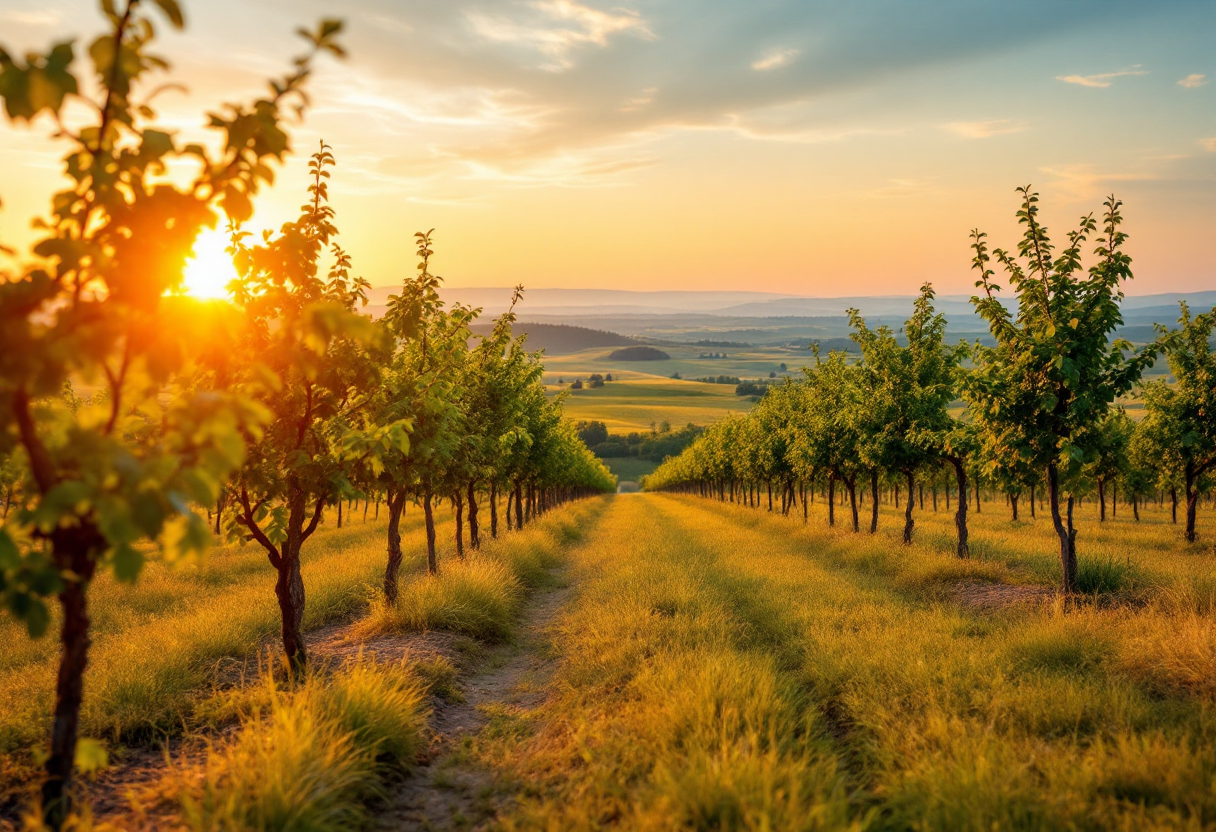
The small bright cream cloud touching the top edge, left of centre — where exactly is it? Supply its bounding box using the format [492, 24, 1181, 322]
[465, 0, 654, 72]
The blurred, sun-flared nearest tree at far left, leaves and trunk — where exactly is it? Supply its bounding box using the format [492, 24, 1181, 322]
[0, 0, 340, 826]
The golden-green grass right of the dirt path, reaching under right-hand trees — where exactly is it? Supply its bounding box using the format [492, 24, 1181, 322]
[454, 495, 1216, 831]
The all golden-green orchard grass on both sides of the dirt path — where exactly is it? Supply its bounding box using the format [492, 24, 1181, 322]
[0, 494, 1216, 832]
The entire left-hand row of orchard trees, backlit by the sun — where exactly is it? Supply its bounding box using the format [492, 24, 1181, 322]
[0, 0, 614, 828]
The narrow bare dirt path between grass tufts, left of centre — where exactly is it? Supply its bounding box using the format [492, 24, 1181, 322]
[378, 573, 573, 832]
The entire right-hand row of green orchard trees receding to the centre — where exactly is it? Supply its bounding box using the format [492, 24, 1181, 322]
[644, 186, 1216, 592]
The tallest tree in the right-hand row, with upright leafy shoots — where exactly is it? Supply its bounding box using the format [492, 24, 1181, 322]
[967, 186, 1156, 591]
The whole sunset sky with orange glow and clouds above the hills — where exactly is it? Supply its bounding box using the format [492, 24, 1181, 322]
[0, 0, 1216, 297]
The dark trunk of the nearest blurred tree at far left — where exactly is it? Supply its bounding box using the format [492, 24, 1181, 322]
[41, 524, 106, 830]
